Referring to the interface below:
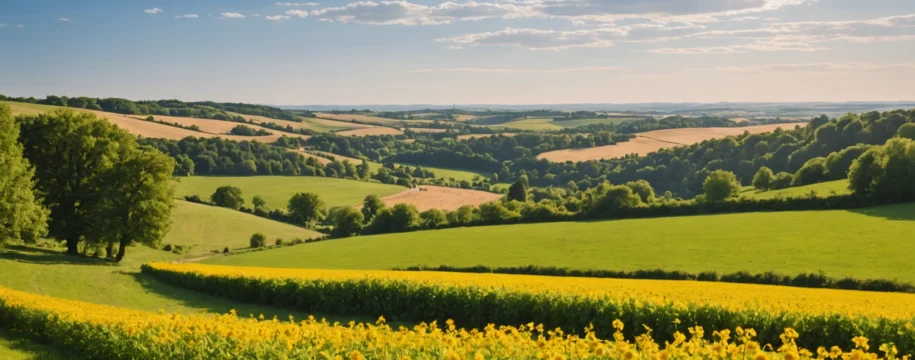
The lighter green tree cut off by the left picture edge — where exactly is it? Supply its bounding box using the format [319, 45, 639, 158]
[0, 104, 47, 246]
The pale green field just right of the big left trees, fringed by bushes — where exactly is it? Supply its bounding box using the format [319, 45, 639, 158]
[175, 176, 406, 208]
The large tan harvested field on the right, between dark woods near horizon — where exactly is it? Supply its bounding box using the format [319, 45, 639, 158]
[537, 124, 797, 162]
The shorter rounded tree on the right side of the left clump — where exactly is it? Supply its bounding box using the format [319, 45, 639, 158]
[92, 148, 175, 261]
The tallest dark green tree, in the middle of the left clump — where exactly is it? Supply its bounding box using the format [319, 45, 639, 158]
[19, 110, 136, 254]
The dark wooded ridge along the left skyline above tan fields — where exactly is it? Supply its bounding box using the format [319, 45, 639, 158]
[0, 95, 314, 121]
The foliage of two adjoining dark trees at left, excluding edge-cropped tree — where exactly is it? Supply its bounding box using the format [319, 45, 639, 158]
[18, 110, 174, 258]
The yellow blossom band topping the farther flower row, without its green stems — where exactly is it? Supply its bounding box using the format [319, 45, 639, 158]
[151, 263, 915, 320]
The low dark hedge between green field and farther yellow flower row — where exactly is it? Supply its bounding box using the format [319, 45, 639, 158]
[392, 265, 915, 293]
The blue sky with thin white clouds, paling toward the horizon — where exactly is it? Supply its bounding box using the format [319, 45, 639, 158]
[0, 0, 915, 105]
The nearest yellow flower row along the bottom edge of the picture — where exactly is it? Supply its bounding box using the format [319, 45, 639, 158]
[0, 287, 908, 360]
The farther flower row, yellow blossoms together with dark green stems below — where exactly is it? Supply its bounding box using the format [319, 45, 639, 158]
[143, 264, 915, 353]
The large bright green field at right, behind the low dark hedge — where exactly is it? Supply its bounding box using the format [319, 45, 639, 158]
[208, 204, 915, 282]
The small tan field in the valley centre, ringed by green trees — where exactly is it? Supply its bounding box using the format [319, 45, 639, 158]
[381, 185, 502, 211]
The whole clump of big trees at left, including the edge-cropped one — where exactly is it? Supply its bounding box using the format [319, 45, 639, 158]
[0, 105, 174, 261]
